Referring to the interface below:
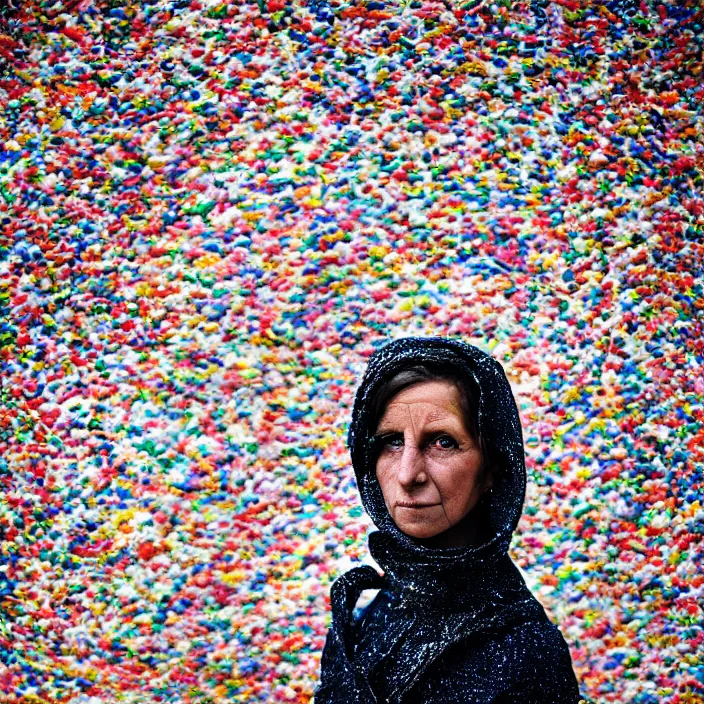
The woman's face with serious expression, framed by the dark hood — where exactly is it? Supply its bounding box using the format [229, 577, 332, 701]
[376, 380, 491, 544]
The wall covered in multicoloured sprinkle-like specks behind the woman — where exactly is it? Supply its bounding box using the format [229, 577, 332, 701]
[0, 0, 704, 704]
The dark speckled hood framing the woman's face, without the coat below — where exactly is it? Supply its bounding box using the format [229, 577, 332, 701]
[348, 337, 526, 567]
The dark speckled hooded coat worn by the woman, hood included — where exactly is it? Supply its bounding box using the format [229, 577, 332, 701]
[315, 337, 580, 704]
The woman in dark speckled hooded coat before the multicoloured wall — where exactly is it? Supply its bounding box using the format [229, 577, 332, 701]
[315, 337, 580, 704]
